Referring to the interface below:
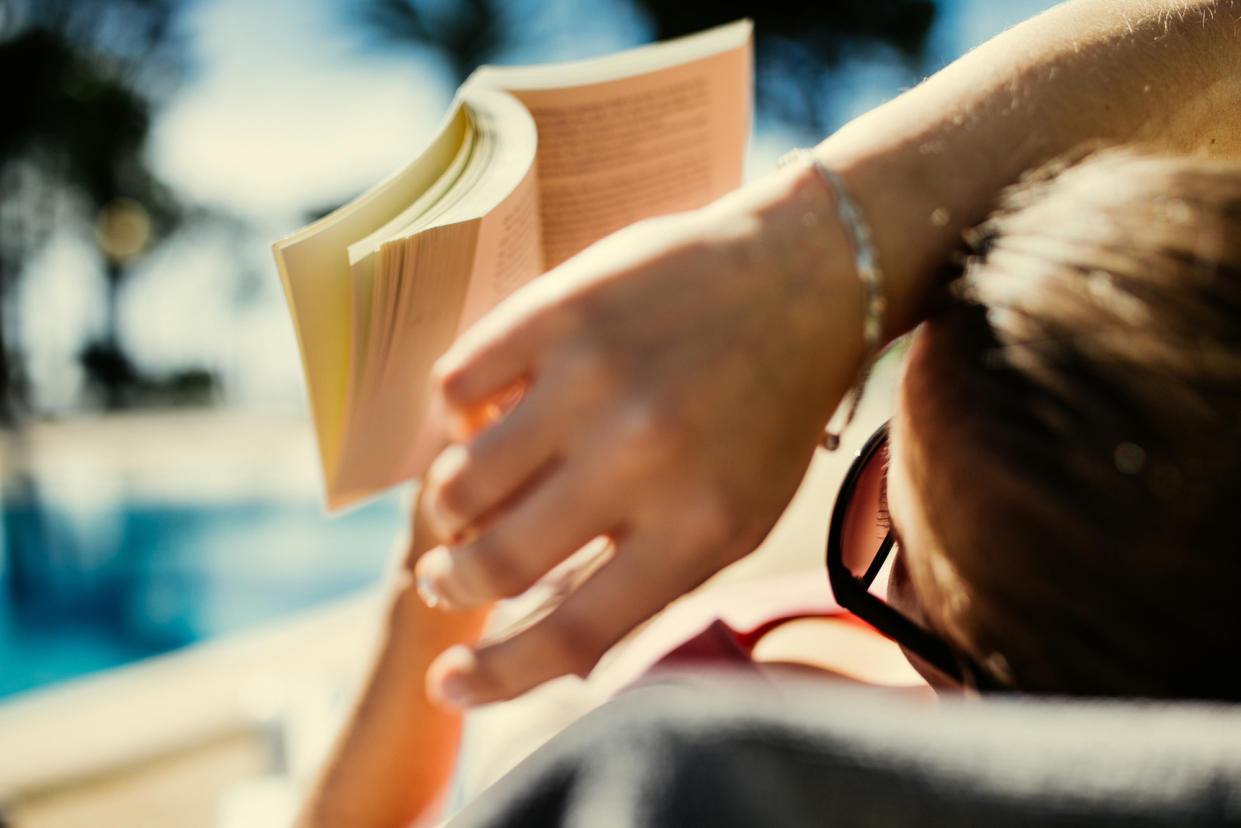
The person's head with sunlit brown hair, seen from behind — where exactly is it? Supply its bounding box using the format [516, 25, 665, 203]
[890, 153, 1241, 698]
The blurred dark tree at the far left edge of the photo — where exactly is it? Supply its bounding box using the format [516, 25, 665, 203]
[0, 0, 182, 414]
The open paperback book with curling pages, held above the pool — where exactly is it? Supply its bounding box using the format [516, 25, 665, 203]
[274, 21, 751, 509]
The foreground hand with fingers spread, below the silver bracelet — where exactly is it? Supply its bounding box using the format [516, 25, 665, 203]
[417, 170, 861, 705]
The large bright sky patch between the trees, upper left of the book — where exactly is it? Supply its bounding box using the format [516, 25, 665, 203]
[151, 0, 450, 218]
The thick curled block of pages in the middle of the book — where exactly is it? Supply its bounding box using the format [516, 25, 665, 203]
[329, 89, 542, 508]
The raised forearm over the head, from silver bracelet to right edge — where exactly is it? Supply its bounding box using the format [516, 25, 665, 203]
[817, 0, 1241, 334]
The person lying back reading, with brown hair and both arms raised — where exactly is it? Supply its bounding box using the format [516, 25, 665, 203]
[292, 0, 1241, 826]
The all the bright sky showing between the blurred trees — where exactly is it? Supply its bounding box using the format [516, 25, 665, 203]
[20, 0, 1051, 411]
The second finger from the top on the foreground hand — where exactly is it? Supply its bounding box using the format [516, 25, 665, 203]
[426, 386, 560, 538]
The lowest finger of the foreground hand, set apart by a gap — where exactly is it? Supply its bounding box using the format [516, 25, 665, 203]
[427, 538, 702, 708]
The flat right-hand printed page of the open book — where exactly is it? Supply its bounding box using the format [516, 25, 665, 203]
[478, 24, 751, 268]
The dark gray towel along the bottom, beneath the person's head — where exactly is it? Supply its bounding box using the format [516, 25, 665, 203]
[450, 675, 1241, 828]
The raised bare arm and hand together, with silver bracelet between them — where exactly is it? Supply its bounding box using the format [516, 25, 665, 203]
[418, 0, 1241, 706]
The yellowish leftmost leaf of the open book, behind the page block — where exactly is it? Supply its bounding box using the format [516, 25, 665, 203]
[273, 104, 467, 487]
